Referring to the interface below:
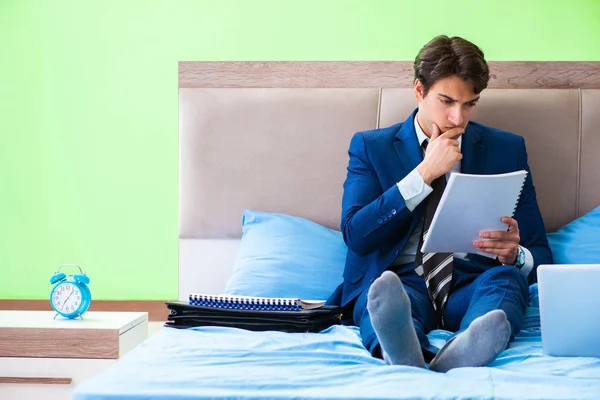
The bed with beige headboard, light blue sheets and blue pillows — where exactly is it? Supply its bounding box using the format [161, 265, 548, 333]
[73, 62, 600, 400]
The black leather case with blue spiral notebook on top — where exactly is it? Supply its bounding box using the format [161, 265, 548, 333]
[165, 294, 342, 332]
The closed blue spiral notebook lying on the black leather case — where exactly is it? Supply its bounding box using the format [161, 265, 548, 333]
[189, 293, 325, 311]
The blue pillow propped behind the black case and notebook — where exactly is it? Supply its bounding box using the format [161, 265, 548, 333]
[225, 210, 347, 300]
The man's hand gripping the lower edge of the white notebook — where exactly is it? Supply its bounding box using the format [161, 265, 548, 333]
[473, 217, 521, 265]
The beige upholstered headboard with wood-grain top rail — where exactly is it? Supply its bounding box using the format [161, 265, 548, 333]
[179, 62, 600, 298]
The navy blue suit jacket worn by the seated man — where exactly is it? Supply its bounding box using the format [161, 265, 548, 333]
[330, 110, 552, 305]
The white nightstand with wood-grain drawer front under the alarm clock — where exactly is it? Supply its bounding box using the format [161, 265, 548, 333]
[0, 311, 148, 400]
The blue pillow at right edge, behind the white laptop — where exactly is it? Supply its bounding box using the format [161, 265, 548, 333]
[548, 207, 600, 264]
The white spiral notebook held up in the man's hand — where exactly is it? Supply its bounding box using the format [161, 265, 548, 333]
[421, 170, 527, 258]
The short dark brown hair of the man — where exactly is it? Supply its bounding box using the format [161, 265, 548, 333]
[414, 35, 490, 97]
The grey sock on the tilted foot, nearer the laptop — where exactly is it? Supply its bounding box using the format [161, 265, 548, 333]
[429, 310, 510, 372]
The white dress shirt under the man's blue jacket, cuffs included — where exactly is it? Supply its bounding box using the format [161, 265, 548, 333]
[394, 115, 533, 278]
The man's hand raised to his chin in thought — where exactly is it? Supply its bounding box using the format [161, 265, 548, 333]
[417, 123, 465, 186]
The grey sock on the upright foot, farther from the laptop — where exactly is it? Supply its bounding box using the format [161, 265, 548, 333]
[367, 271, 425, 368]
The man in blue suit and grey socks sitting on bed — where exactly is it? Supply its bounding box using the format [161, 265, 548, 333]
[337, 36, 552, 372]
